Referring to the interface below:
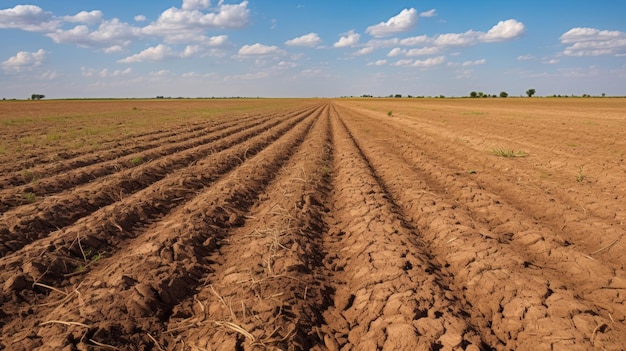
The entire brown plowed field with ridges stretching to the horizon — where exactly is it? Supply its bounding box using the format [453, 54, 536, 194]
[0, 98, 626, 351]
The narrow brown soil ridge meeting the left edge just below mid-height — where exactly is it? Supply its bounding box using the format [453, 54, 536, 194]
[0, 111, 270, 212]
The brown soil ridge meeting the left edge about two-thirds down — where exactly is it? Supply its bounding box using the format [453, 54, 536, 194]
[0, 108, 308, 256]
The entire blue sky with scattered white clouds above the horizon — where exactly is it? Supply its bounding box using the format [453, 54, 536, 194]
[0, 0, 626, 98]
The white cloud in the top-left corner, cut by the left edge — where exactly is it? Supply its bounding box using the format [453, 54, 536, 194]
[0, 5, 61, 32]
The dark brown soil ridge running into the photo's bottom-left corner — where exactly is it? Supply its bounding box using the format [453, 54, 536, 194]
[4, 103, 320, 349]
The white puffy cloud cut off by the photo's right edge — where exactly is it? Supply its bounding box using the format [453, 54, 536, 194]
[559, 28, 626, 56]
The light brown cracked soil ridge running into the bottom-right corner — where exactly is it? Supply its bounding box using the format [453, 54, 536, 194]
[334, 102, 626, 350]
